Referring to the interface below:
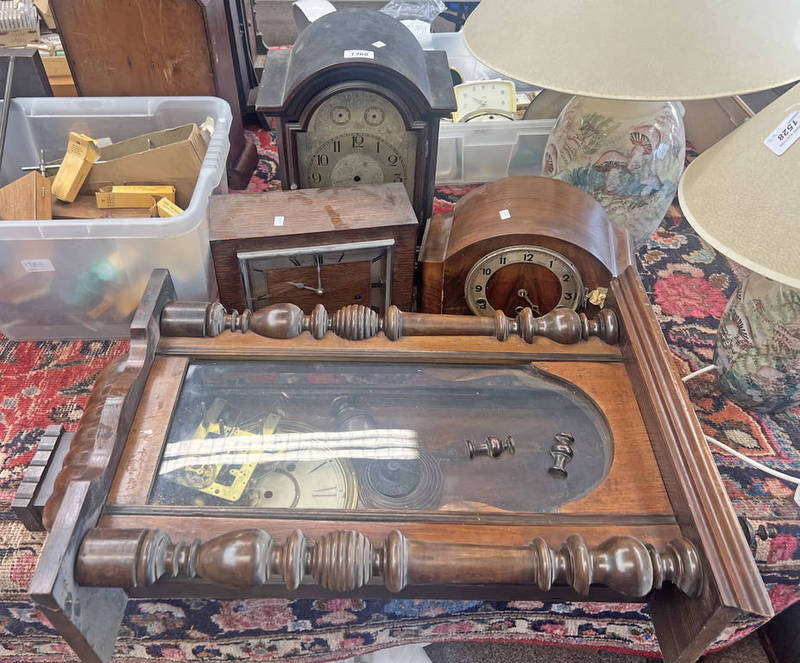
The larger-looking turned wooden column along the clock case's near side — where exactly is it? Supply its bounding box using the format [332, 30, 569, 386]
[75, 529, 703, 597]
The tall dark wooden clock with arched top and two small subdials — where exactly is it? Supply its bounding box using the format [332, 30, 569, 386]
[256, 9, 456, 222]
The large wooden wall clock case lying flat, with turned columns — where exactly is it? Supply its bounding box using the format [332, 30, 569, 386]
[14, 254, 772, 663]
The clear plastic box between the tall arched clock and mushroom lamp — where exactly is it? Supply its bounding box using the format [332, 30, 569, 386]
[436, 119, 556, 184]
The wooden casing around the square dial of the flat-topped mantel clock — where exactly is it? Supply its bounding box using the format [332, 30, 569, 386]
[210, 184, 417, 312]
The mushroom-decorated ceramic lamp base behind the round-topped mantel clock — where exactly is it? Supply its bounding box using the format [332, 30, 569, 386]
[542, 97, 686, 247]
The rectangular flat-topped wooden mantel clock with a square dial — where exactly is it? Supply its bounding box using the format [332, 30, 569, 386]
[209, 183, 418, 313]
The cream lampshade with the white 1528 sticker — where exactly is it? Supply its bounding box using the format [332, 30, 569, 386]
[678, 84, 800, 288]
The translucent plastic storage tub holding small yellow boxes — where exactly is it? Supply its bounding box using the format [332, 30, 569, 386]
[0, 97, 231, 340]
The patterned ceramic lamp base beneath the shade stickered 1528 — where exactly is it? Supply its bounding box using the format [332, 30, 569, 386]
[714, 273, 800, 412]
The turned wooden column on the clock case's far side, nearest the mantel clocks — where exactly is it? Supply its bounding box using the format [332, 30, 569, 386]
[161, 302, 619, 344]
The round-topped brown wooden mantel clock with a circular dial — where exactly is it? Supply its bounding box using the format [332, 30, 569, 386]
[419, 176, 631, 316]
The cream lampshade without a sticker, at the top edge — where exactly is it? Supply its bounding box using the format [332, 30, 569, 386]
[464, 0, 800, 101]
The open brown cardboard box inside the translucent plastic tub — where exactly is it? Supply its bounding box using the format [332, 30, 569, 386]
[81, 124, 206, 209]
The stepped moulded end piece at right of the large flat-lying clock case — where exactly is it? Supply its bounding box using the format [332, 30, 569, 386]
[612, 267, 773, 661]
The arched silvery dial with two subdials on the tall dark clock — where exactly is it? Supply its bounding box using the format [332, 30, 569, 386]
[297, 90, 417, 200]
